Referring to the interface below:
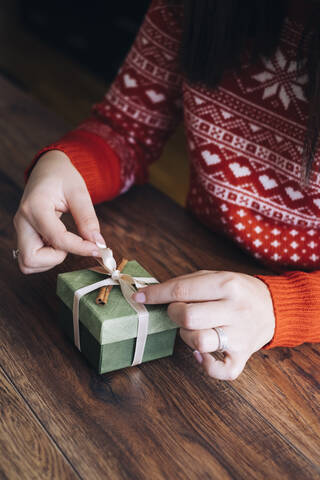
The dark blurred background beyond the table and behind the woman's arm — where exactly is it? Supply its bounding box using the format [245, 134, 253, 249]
[0, 0, 189, 205]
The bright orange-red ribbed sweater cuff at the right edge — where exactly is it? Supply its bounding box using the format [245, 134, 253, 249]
[256, 271, 320, 349]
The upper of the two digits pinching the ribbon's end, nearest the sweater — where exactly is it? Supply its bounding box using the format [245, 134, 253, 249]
[67, 188, 106, 247]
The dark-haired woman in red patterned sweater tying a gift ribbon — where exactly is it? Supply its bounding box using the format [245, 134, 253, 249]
[14, 0, 320, 380]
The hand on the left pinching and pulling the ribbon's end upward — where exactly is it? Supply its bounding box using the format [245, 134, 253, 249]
[13, 150, 105, 274]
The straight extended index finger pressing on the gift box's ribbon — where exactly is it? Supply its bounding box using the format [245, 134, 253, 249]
[134, 272, 229, 304]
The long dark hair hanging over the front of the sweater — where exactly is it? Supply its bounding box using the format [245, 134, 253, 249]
[180, 0, 320, 181]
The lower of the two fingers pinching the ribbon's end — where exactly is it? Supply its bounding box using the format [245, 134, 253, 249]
[31, 206, 99, 256]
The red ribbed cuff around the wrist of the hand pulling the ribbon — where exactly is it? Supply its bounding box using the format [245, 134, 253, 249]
[24, 129, 120, 204]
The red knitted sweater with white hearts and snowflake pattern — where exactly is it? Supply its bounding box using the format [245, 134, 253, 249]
[26, 0, 320, 348]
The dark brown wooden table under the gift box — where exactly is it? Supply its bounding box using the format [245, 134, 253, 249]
[0, 79, 320, 480]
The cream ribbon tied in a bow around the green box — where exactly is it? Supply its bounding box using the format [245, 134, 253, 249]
[73, 247, 158, 366]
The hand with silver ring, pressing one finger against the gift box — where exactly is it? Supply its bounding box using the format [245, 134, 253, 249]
[133, 270, 275, 380]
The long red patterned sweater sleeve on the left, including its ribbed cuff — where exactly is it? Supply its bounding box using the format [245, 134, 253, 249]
[25, 0, 183, 203]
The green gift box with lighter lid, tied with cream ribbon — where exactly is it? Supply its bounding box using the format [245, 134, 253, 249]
[57, 260, 177, 373]
